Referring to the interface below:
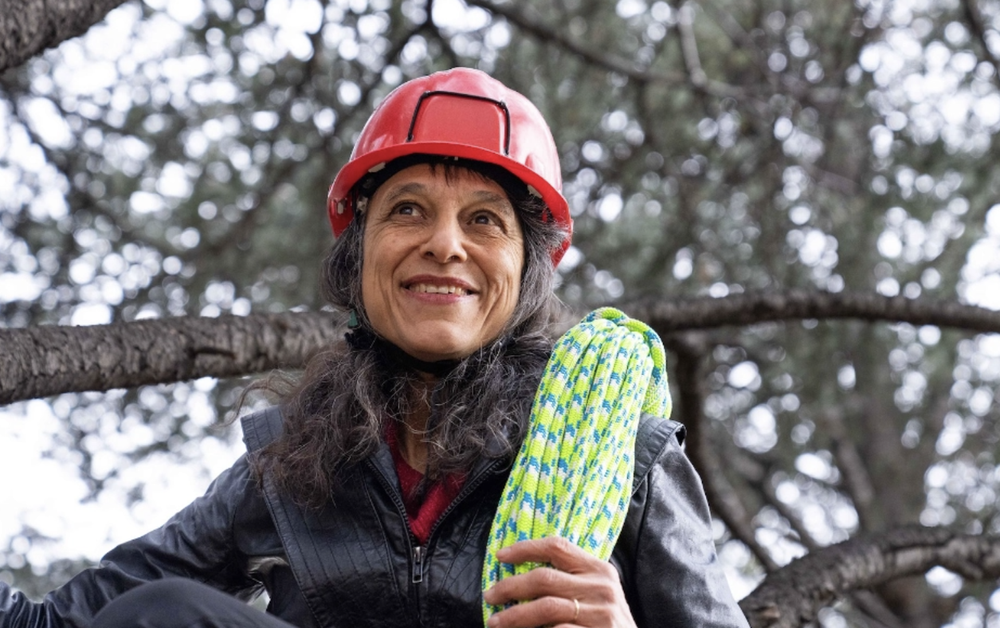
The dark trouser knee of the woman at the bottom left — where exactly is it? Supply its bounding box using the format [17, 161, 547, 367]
[93, 578, 294, 628]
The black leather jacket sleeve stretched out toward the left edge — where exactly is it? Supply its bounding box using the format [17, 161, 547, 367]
[0, 456, 260, 628]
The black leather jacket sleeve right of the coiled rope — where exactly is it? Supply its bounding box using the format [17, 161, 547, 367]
[612, 419, 748, 628]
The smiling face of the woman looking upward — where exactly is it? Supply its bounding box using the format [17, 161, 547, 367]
[361, 164, 524, 361]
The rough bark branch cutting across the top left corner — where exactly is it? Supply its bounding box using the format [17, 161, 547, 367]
[0, 0, 131, 73]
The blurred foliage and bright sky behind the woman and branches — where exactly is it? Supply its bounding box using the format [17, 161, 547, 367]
[0, 0, 1000, 627]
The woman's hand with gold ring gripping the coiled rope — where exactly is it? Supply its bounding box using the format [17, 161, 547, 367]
[483, 537, 635, 628]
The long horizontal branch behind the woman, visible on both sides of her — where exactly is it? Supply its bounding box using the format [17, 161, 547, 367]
[0, 288, 1000, 404]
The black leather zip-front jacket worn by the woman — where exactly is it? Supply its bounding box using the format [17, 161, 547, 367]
[0, 409, 747, 628]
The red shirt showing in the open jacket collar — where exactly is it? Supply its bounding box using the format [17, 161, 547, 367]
[385, 426, 465, 544]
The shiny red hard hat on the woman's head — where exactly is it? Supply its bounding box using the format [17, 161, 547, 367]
[327, 68, 573, 266]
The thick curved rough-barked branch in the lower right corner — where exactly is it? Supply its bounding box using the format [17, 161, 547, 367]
[740, 527, 1000, 628]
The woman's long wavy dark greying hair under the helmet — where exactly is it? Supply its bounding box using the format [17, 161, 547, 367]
[253, 159, 564, 507]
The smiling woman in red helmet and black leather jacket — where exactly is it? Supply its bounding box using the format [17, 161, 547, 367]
[0, 69, 746, 627]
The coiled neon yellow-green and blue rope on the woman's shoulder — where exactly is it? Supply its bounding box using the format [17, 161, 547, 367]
[483, 308, 671, 624]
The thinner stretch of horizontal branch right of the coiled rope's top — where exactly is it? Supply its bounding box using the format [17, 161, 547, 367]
[621, 290, 1000, 333]
